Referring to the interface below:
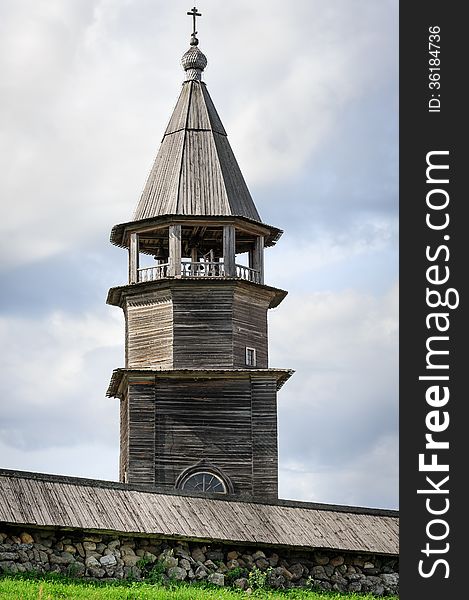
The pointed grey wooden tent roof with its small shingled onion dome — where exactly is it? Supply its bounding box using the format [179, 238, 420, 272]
[134, 37, 261, 221]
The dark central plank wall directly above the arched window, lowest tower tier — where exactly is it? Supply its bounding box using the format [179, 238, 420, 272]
[156, 378, 252, 495]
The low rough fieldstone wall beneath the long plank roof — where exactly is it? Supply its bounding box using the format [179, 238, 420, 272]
[0, 526, 399, 596]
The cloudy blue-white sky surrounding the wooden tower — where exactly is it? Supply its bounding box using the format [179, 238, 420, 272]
[0, 0, 398, 508]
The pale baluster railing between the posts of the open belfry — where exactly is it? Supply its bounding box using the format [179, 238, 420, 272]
[138, 261, 261, 283]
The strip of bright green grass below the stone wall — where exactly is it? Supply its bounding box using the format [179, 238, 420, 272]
[0, 575, 397, 600]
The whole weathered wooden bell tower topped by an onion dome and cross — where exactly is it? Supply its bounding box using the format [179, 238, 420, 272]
[107, 9, 292, 499]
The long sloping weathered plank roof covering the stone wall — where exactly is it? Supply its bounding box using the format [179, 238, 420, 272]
[0, 469, 399, 555]
